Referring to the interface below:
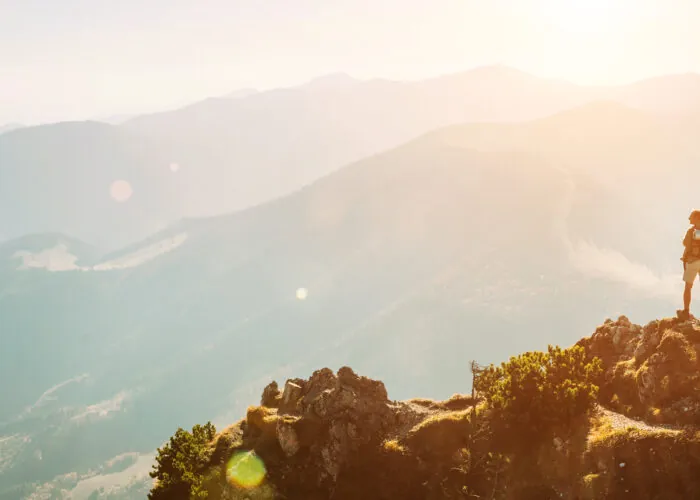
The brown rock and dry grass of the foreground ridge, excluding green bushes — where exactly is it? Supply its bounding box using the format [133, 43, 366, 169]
[159, 316, 700, 500]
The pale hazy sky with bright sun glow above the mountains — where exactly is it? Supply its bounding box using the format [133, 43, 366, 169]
[0, 0, 700, 125]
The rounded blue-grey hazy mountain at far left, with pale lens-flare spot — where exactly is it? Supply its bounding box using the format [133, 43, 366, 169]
[0, 122, 181, 248]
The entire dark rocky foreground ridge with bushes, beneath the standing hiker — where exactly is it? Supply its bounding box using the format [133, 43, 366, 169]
[149, 316, 700, 500]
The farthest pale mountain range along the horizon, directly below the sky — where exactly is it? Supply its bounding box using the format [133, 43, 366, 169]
[0, 66, 700, 250]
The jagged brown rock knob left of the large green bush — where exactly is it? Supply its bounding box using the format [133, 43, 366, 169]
[242, 367, 432, 498]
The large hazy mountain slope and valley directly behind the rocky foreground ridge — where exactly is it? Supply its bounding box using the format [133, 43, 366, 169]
[0, 99, 700, 498]
